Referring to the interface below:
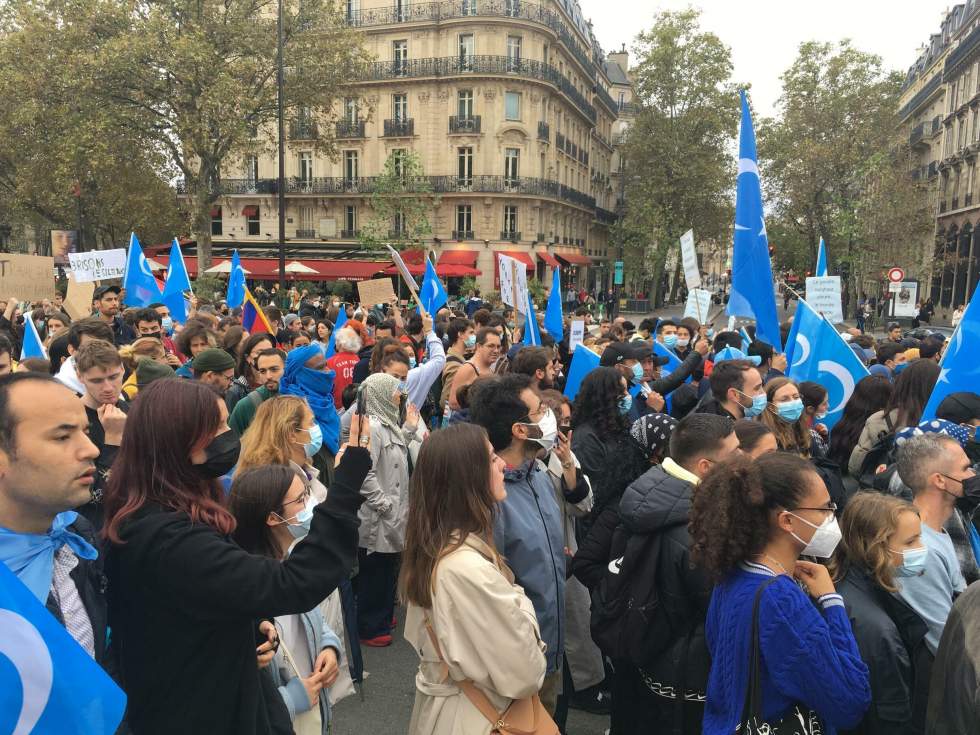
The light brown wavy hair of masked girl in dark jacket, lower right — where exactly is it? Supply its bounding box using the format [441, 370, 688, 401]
[828, 492, 919, 593]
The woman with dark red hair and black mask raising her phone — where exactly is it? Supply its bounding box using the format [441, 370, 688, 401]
[103, 380, 371, 735]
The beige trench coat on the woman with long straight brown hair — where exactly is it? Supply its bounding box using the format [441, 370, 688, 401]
[405, 535, 545, 735]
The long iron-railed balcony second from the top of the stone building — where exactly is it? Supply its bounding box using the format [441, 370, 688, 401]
[360, 55, 596, 124]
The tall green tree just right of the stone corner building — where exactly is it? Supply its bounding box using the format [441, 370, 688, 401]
[613, 9, 739, 304]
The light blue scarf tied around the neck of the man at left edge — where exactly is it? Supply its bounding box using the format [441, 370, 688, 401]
[0, 510, 99, 605]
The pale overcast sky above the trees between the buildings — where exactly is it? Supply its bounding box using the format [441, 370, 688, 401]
[579, 0, 954, 115]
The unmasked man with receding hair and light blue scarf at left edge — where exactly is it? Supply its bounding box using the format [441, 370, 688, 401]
[0, 372, 107, 666]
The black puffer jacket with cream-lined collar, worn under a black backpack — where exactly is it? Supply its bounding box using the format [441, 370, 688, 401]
[619, 465, 712, 694]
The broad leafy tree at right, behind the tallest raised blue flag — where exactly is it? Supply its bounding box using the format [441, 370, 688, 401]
[759, 41, 925, 308]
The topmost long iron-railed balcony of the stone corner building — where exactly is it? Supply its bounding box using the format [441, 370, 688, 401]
[346, 0, 596, 77]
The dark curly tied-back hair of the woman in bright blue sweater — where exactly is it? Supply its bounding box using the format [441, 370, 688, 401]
[690, 452, 820, 582]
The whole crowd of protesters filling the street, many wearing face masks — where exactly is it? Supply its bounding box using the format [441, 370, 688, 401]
[0, 278, 980, 735]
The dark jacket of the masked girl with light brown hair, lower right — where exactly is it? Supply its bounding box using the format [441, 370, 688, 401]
[837, 567, 932, 735]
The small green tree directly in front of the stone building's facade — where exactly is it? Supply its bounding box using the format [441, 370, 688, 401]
[359, 150, 440, 250]
